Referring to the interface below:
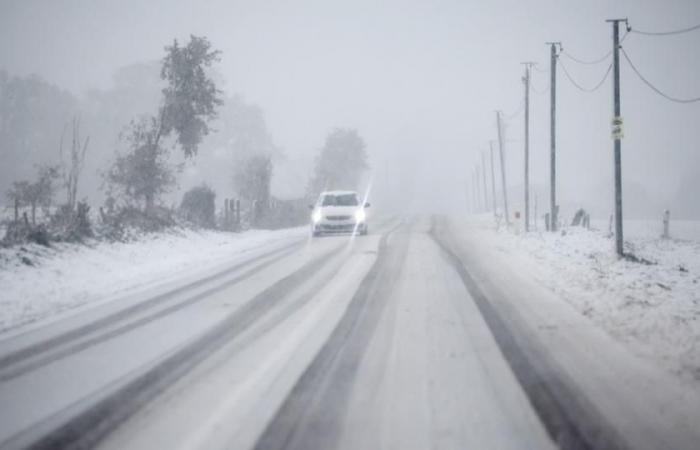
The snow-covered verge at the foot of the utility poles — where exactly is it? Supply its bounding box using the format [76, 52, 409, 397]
[475, 217, 700, 384]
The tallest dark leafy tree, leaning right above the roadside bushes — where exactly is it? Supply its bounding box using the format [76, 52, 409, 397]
[106, 36, 222, 213]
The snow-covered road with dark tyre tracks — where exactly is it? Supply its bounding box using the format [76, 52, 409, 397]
[0, 217, 700, 449]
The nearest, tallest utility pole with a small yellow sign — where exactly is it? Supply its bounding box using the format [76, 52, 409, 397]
[606, 19, 627, 257]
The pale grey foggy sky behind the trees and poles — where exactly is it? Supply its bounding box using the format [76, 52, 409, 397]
[0, 0, 700, 218]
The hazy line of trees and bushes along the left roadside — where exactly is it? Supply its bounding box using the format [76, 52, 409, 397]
[0, 32, 368, 250]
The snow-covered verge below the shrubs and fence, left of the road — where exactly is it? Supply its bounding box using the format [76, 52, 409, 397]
[0, 227, 308, 332]
